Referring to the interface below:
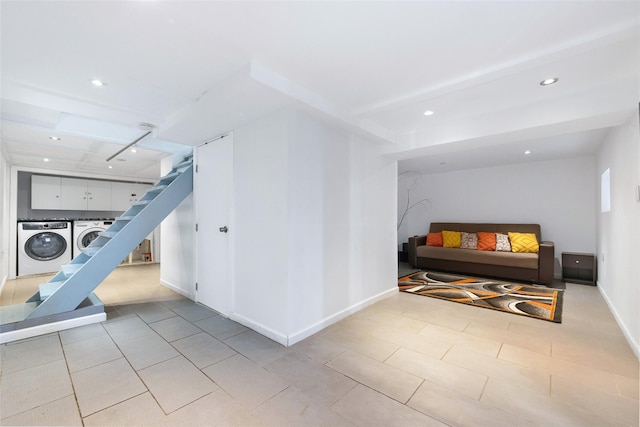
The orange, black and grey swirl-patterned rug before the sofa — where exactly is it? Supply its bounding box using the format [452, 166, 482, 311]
[398, 271, 564, 323]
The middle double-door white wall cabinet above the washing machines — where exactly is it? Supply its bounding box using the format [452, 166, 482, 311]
[61, 178, 111, 211]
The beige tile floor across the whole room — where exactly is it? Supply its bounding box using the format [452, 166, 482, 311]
[0, 265, 639, 427]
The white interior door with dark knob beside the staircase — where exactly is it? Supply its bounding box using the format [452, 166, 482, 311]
[194, 134, 233, 315]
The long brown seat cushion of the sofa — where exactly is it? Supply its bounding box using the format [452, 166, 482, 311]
[416, 246, 538, 269]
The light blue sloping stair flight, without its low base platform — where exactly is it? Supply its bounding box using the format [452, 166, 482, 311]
[26, 163, 193, 319]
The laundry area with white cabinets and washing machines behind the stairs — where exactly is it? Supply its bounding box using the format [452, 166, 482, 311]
[16, 171, 159, 277]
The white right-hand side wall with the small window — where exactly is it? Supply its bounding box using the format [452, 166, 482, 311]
[597, 116, 640, 357]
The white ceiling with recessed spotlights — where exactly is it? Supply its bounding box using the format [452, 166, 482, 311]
[0, 1, 640, 178]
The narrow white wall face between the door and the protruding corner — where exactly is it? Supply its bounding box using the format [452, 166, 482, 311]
[232, 113, 289, 341]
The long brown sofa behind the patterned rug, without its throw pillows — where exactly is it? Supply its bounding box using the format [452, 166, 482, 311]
[409, 222, 555, 284]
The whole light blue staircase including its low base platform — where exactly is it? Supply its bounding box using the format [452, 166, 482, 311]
[0, 157, 193, 340]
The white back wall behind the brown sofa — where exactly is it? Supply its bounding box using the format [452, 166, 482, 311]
[398, 156, 599, 274]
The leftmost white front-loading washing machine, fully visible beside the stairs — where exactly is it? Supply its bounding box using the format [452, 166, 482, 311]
[18, 221, 73, 276]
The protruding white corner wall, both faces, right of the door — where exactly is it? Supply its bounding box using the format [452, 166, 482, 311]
[231, 111, 397, 345]
